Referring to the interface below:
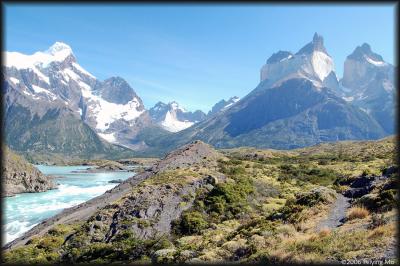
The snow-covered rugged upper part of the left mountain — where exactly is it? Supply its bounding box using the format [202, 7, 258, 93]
[5, 42, 150, 148]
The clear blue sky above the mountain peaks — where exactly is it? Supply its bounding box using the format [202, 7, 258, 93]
[4, 4, 395, 112]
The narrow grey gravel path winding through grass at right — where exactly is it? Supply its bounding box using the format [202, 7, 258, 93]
[315, 193, 350, 232]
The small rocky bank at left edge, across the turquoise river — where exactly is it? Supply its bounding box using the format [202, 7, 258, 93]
[2, 146, 56, 197]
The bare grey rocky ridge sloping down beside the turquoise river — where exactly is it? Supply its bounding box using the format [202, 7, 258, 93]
[5, 141, 224, 249]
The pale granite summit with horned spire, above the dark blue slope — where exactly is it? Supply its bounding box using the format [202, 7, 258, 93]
[260, 33, 338, 87]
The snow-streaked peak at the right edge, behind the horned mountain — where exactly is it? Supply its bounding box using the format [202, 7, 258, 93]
[340, 43, 396, 134]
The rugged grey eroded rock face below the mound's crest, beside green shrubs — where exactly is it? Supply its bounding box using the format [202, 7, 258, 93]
[66, 176, 212, 246]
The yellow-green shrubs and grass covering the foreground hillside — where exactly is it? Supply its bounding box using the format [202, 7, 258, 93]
[4, 138, 398, 263]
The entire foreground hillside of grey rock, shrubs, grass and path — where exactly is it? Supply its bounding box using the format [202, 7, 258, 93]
[4, 138, 397, 263]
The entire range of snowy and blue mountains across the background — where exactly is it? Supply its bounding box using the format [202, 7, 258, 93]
[4, 33, 396, 157]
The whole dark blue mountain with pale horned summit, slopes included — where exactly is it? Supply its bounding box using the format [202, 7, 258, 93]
[143, 34, 387, 155]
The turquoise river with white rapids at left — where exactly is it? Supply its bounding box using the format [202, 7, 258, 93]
[3, 165, 134, 243]
